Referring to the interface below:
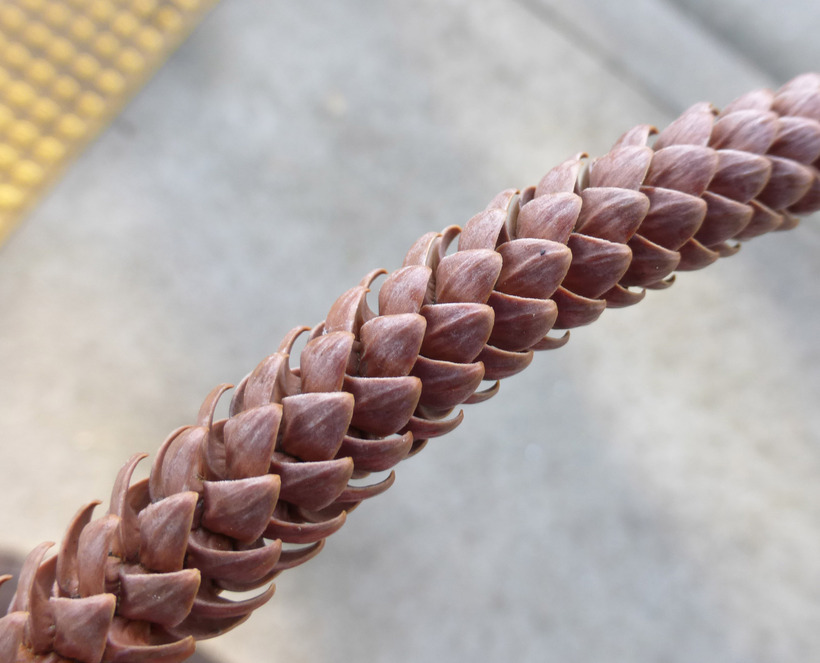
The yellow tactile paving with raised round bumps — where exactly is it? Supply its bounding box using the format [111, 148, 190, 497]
[0, 0, 216, 242]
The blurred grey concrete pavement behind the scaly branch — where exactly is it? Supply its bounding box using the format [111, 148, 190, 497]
[0, 0, 820, 663]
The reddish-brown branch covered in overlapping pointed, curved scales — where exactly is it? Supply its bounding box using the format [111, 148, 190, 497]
[0, 74, 820, 663]
